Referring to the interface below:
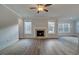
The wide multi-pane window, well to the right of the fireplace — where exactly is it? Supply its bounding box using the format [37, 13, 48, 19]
[58, 23, 70, 33]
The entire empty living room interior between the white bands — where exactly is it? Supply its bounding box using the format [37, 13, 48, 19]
[0, 4, 79, 55]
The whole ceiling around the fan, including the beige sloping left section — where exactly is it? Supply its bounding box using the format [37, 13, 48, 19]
[0, 4, 79, 28]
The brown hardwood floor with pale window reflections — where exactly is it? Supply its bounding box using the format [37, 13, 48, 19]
[0, 39, 76, 55]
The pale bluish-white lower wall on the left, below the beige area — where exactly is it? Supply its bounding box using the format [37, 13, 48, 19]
[0, 24, 18, 50]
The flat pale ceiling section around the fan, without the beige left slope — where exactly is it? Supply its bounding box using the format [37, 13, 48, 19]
[2, 4, 79, 19]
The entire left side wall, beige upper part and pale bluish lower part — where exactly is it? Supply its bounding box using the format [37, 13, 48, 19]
[0, 5, 18, 50]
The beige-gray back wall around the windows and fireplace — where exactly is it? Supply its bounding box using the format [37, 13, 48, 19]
[20, 16, 76, 38]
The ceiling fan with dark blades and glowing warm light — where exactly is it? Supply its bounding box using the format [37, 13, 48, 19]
[30, 4, 52, 13]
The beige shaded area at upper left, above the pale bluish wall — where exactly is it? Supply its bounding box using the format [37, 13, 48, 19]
[0, 5, 18, 29]
